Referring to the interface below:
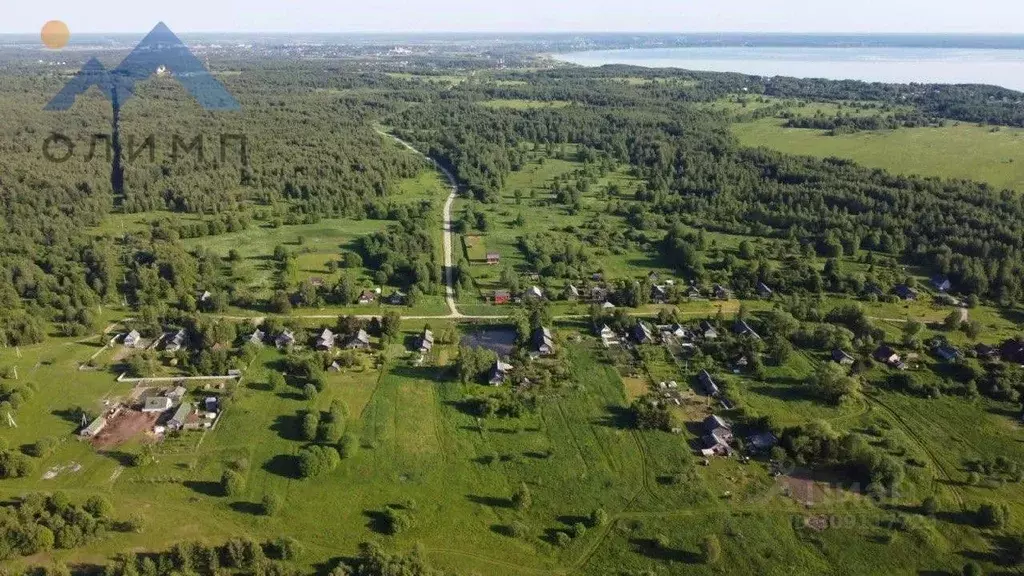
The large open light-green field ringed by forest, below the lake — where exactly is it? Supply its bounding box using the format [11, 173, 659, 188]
[733, 118, 1024, 191]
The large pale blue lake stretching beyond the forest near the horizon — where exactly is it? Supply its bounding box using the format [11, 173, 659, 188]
[555, 47, 1024, 91]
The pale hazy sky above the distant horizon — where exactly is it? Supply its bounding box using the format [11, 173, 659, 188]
[6, 0, 1024, 35]
